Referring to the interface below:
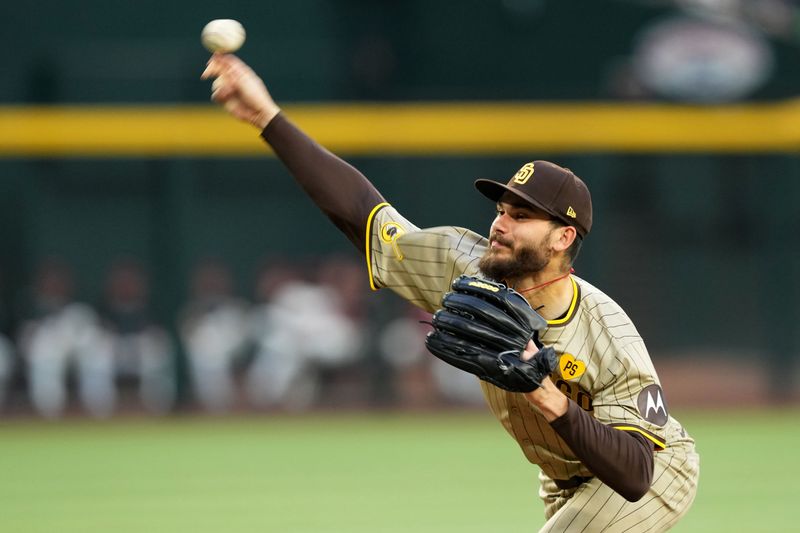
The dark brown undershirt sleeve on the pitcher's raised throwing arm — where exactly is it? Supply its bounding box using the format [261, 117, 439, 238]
[261, 113, 384, 253]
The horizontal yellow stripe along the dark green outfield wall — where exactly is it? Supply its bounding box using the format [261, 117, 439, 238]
[0, 100, 800, 157]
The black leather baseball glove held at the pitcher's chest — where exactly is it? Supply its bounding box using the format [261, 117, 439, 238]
[425, 276, 558, 392]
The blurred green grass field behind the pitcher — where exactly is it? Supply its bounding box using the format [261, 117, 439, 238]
[0, 410, 800, 533]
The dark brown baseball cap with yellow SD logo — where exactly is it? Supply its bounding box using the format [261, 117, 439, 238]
[475, 161, 592, 237]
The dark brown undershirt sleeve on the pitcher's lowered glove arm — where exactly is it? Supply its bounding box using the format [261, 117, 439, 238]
[550, 400, 653, 502]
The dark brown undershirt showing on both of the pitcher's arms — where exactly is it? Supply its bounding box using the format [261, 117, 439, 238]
[261, 113, 654, 501]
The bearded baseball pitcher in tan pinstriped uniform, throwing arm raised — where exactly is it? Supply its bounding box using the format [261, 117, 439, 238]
[203, 54, 699, 532]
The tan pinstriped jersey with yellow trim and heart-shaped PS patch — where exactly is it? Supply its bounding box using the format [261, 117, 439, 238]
[366, 204, 694, 479]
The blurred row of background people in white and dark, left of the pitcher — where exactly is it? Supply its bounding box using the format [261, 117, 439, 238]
[0, 256, 488, 418]
